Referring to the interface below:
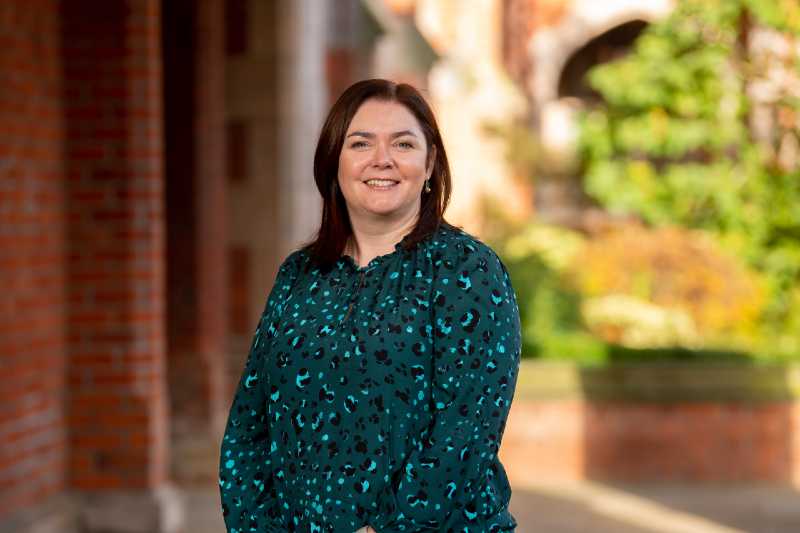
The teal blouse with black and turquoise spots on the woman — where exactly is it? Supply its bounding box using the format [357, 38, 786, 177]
[219, 224, 520, 533]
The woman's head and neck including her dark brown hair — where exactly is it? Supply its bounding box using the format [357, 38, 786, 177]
[298, 80, 451, 270]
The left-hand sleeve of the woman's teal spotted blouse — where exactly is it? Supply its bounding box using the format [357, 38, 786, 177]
[219, 252, 298, 533]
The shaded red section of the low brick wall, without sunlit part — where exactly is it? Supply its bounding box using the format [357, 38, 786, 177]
[584, 402, 800, 483]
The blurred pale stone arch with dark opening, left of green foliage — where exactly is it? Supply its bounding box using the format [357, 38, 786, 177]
[526, 0, 671, 228]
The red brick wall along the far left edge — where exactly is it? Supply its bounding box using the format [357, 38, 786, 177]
[0, 0, 66, 516]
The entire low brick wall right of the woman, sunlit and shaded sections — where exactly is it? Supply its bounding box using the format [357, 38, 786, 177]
[500, 399, 800, 486]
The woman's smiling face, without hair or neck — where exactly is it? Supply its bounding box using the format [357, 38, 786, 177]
[338, 99, 433, 221]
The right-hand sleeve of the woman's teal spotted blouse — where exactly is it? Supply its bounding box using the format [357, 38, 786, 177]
[371, 244, 521, 533]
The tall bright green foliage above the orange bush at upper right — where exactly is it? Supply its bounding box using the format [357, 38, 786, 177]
[581, 0, 800, 344]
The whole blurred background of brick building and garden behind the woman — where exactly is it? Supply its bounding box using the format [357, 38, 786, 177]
[0, 0, 800, 533]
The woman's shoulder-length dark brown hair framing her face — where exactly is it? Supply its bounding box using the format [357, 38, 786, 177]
[303, 79, 452, 269]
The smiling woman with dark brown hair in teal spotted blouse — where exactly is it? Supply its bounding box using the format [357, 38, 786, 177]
[219, 79, 520, 533]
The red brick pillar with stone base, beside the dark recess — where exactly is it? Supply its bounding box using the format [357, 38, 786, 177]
[60, 0, 181, 533]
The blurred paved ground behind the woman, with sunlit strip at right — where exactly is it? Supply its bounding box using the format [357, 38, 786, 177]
[186, 483, 800, 533]
